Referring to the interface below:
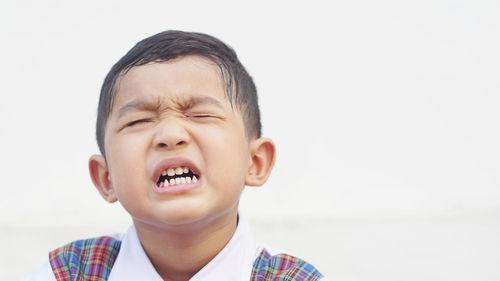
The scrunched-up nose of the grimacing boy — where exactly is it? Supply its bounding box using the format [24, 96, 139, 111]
[153, 118, 191, 149]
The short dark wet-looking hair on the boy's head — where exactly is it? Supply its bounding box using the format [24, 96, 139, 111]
[96, 30, 261, 155]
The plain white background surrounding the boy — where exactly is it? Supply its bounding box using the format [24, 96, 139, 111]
[0, 0, 500, 281]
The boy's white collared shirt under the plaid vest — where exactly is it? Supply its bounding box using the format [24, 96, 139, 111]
[23, 219, 327, 281]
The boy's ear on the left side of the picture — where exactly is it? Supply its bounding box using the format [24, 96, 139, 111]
[89, 155, 118, 203]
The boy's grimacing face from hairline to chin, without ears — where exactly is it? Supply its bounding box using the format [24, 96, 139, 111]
[98, 56, 251, 226]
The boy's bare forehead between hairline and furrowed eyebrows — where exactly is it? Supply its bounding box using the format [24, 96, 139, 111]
[113, 56, 228, 112]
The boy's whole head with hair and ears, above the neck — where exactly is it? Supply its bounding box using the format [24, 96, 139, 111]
[89, 31, 275, 227]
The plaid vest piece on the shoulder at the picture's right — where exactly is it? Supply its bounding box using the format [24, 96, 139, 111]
[250, 249, 323, 281]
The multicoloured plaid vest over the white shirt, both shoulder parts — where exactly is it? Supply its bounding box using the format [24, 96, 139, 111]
[49, 236, 323, 281]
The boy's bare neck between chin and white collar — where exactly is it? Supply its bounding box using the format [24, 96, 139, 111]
[134, 211, 237, 281]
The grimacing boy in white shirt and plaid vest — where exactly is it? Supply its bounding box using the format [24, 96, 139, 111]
[25, 31, 325, 281]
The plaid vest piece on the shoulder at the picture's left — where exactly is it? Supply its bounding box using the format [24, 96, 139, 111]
[49, 236, 121, 281]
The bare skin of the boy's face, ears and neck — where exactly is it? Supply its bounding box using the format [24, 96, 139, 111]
[89, 56, 275, 280]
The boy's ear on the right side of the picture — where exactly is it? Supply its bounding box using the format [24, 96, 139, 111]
[245, 138, 276, 186]
